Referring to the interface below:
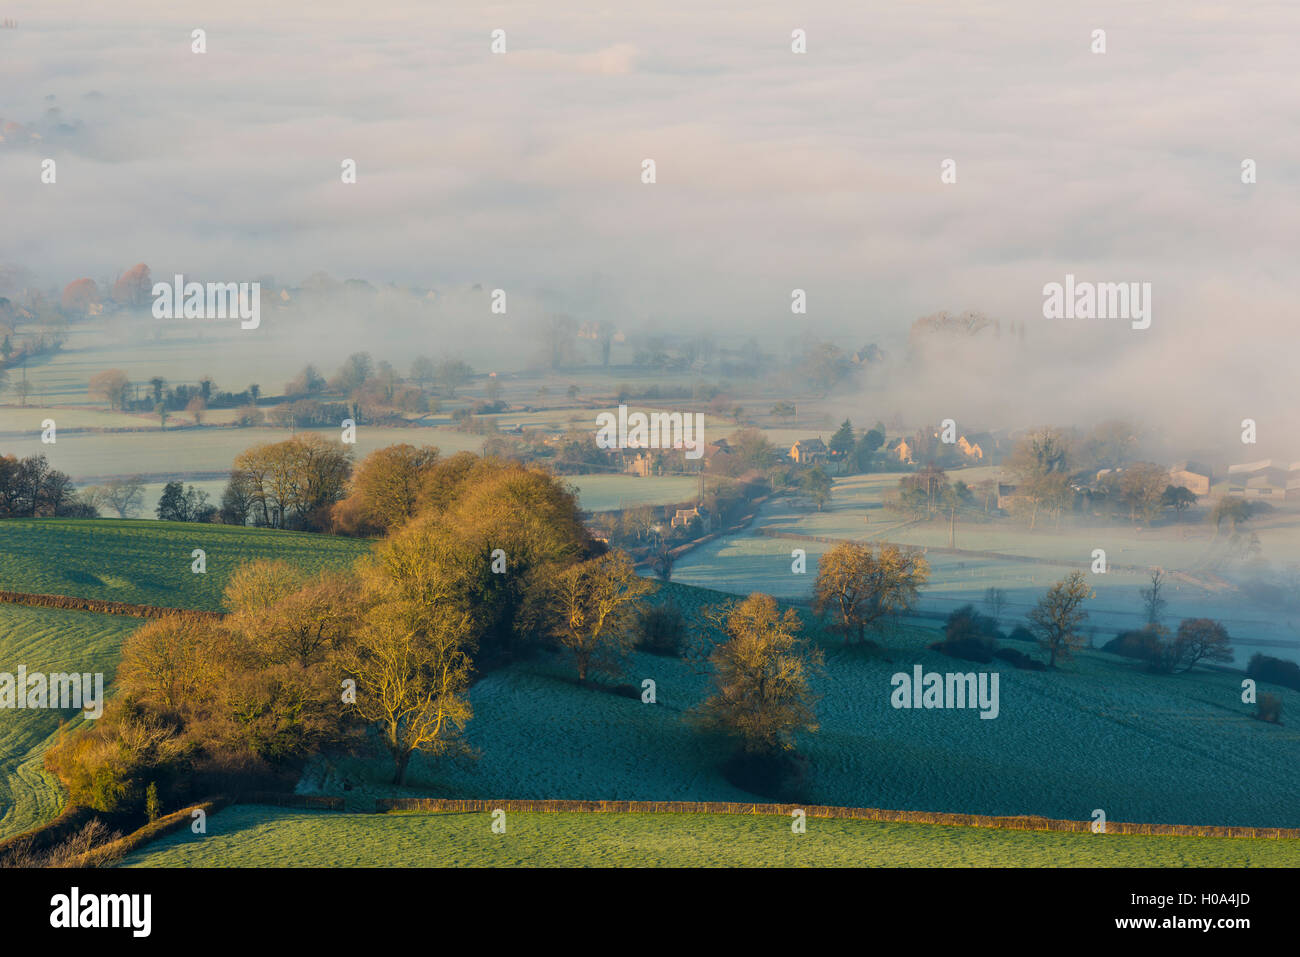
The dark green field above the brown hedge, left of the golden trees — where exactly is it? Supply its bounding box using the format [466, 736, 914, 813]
[0, 519, 369, 611]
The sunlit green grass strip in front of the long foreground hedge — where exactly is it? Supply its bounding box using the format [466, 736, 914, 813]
[124, 805, 1300, 867]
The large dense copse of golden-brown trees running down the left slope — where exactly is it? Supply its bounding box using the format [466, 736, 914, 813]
[48, 455, 618, 813]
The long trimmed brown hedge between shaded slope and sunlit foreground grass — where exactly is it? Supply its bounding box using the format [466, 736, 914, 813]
[376, 797, 1300, 840]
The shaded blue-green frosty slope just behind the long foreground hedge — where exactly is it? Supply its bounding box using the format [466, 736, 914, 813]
[299, 585, 1300, 827]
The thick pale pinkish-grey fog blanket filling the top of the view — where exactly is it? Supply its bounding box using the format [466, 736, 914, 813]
[0, 0, 1300, 444]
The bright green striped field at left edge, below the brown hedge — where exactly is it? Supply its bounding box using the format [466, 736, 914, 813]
[0, 605, 140, 837]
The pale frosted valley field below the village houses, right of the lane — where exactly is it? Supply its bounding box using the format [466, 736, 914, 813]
[673, 478, 1300, 667]
